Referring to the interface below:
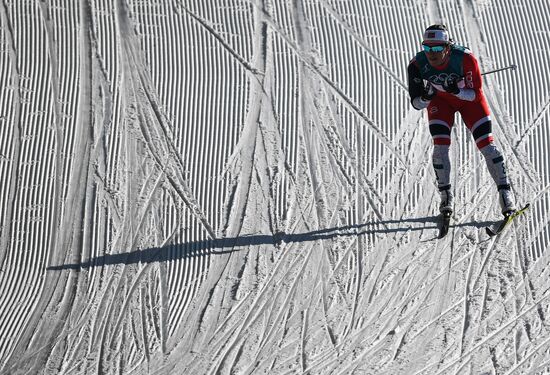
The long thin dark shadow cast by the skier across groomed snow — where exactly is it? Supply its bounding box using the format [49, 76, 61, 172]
[46, 216, 492, 271]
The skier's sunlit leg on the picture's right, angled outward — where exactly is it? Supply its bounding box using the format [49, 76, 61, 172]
[461, 100, 515, 215]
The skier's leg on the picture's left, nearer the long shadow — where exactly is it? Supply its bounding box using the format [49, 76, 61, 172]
[428, 98, 454, 212]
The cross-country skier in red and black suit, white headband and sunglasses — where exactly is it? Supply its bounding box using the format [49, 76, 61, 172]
[408, 25, 515, 216]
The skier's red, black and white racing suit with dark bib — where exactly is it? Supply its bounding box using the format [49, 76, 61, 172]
[407, 45, 510, 212]
